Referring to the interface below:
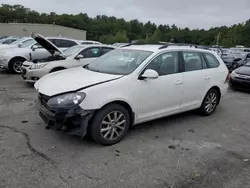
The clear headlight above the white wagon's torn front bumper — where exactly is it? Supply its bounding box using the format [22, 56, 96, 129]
[47, 92, 86, 108]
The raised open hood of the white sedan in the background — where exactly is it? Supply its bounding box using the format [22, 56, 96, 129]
[31, 32, 65, 56]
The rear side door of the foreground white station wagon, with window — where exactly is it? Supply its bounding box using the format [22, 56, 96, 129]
[181, 51, 211, 111]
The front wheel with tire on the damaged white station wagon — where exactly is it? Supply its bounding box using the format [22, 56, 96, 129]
[90, 104, 130, 145]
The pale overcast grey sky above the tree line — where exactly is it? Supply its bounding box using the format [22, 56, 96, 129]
[0, 0, 250, 29]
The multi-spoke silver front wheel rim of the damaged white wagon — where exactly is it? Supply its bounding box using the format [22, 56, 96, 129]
[101, 111, 127, 141]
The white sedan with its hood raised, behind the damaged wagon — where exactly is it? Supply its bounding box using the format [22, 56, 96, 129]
[21, 43, 114, 83]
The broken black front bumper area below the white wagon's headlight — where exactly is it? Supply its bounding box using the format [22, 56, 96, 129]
[37, 99, 94, 138]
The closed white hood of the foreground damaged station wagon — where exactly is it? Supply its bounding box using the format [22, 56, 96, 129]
[35, 67, 123, 96]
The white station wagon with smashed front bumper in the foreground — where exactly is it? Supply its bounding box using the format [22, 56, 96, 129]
[35, 45, 229, 145]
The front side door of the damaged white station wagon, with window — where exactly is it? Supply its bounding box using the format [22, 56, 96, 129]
[137, 51, 183, 122]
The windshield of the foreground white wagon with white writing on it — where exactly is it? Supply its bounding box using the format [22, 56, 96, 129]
[86, 49, 153, 75]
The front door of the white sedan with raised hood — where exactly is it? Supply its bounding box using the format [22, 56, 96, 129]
[72, 47, 101, 67]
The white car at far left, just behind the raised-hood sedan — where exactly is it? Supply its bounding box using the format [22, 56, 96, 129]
[0, 33, 80, 73]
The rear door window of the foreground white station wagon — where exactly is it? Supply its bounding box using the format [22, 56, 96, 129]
[182, 52, 203, 72]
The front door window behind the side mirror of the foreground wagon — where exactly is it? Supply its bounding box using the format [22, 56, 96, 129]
[145, 52, 179, 76]
